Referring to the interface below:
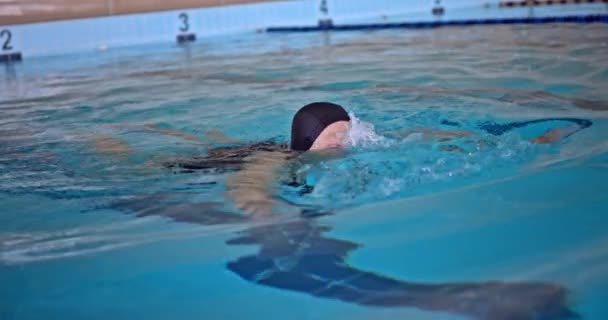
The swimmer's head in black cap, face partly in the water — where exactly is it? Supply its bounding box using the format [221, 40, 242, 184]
[291, 102, 350, 151]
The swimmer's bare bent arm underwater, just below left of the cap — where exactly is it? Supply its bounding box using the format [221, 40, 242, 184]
[226, 152, 296, 217]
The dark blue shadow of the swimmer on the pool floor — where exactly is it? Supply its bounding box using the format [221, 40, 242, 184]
[113, 195, 579, 320]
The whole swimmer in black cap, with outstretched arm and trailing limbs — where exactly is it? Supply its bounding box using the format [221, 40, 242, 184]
[97, 102, 591, 217]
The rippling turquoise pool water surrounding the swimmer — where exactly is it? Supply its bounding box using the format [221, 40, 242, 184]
[0, 25, 608, 319]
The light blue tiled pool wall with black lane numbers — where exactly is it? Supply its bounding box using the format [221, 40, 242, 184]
[0, 0, 608, 60]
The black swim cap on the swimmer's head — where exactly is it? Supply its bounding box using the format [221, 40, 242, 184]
[291, 102, 350, 151]
